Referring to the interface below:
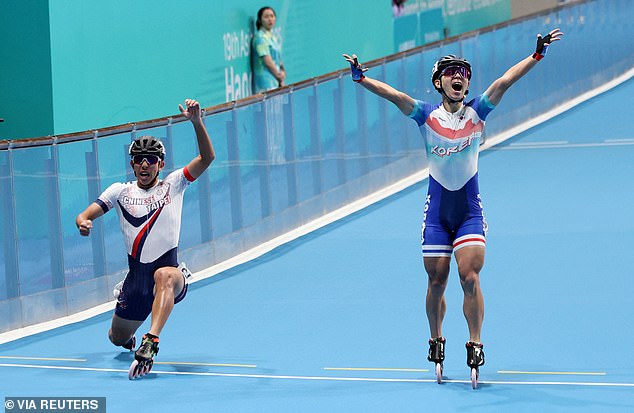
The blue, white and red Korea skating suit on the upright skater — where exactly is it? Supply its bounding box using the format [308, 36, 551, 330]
[409, 95, 495, 257]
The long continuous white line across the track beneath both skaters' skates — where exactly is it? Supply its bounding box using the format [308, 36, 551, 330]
[0, 364, 634, 388]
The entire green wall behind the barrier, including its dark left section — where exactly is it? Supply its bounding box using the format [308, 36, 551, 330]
[0, 0, 510, 139]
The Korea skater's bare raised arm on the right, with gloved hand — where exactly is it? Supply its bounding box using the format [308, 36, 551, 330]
[485, 29, 563, 105]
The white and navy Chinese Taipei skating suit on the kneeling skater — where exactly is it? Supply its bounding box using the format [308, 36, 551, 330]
[96, 168, 194, 321]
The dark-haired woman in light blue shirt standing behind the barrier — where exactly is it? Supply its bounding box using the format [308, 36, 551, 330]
[253, 7, 286, 93]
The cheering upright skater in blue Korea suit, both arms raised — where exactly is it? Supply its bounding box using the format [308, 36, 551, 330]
[343, 29, 563, 386]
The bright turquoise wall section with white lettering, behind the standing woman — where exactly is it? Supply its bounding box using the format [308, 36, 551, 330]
[49, 0, 392, 138]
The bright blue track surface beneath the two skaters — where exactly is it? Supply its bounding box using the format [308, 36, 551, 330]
[0, 81, 634, 413]
